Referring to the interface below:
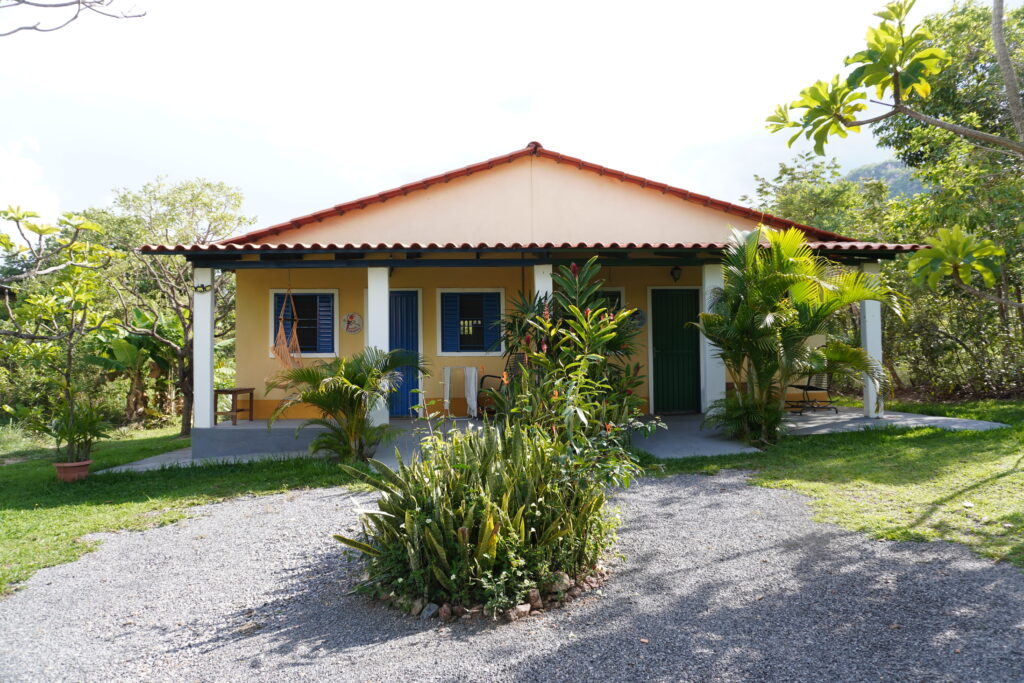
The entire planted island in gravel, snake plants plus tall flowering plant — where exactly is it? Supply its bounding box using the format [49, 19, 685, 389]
[338, 260, 656, 613]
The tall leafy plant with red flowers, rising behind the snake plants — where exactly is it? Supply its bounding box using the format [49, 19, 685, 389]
[481, 258, 664, 483]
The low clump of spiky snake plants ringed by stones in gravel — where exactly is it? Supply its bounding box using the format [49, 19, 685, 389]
[335, 424, 622, 613]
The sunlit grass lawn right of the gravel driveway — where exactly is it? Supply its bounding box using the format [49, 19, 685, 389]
[659, 400, 1024, 568]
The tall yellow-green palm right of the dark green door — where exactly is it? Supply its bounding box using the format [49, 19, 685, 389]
[696, 227, 902, 443]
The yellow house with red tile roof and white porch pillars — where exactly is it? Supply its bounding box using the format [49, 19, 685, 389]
[142, 142, 913, 457]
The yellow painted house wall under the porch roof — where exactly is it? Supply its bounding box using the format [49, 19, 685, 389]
[236, 265, 700, 419]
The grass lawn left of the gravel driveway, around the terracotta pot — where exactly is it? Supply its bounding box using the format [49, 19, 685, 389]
[0, 427, 360, 595]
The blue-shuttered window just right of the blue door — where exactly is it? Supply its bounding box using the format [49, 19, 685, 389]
[441, 292, 502, 355]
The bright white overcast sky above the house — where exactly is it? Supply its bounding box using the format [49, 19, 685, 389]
[0, 0, 974, 225]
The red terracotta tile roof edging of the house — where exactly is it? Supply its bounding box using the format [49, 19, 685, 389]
[140, 142, 920, 254]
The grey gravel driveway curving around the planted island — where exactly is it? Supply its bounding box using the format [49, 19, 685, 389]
[0, 472, 1024, 681]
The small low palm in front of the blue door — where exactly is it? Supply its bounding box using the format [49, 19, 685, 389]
[266, 347, 426, 460]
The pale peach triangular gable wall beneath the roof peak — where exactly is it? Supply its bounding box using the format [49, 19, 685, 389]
[259, 156, 770, 244]
